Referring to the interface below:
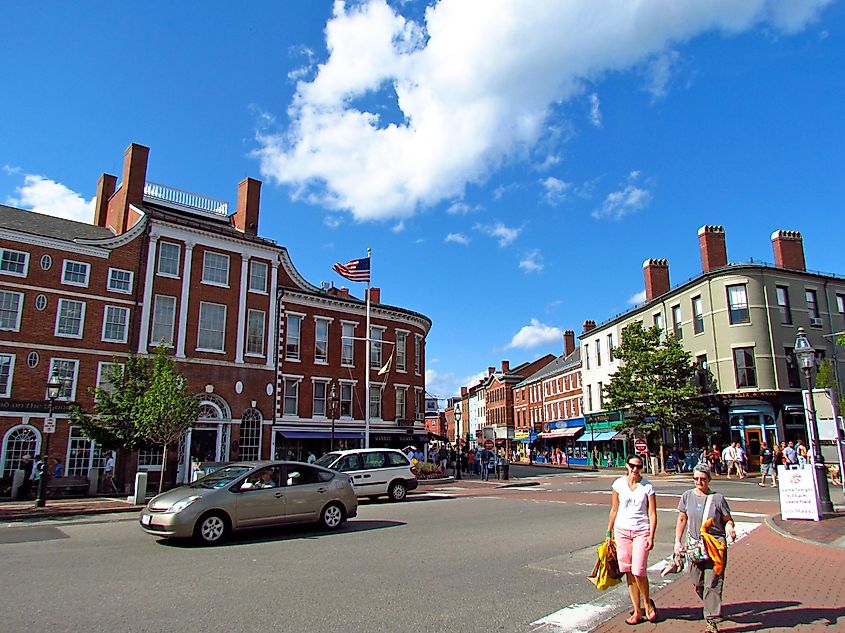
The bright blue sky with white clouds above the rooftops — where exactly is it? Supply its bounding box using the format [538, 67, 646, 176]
[0, 0, 845, 396]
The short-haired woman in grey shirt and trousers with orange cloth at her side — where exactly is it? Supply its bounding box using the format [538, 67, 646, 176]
[675, 465, 736, 633]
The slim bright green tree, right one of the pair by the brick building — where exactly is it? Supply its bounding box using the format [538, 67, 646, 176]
[137, 347, 199, 492]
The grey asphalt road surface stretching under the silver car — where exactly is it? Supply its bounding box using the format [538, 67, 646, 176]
[0, 467, 774, 633]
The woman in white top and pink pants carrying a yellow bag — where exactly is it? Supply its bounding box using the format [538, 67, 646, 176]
[607, 455, 657, 624]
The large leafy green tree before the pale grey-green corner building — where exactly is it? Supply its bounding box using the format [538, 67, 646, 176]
[604, 321, 715, 466]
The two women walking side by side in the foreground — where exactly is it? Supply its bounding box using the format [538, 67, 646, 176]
[606, 455, 736, 633]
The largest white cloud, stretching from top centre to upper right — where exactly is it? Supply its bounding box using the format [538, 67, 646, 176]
[256, 0, 830, 220]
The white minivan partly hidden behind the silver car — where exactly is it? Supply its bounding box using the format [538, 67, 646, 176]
[316, 448, 419, 501]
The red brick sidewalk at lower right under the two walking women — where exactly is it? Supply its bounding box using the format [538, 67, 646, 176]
[592, 525, 845, 633]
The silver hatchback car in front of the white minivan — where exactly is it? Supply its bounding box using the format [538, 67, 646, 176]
[140, 461, 358, 545]
